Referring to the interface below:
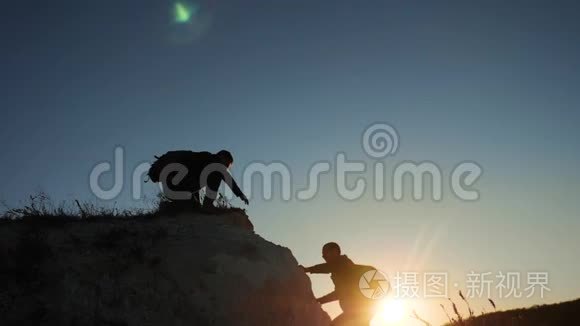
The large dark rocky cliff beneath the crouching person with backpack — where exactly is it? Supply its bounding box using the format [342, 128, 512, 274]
[0, 210, 329, 326]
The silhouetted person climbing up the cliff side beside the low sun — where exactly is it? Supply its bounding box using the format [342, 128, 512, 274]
[301, 242, 377, 326]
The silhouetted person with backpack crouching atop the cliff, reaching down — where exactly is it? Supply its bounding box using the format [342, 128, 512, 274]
[148, 150, 248, 207]
